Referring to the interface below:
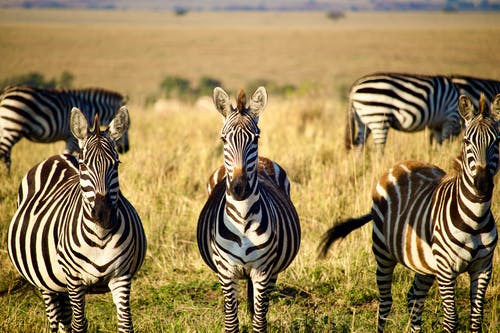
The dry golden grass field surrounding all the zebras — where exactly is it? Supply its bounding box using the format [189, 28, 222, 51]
[0, 10, 500, 332]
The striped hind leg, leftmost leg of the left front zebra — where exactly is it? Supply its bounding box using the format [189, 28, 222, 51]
[40, 290, 71, 333]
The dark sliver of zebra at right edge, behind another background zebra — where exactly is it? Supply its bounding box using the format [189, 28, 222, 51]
[451, 75, 500, 108]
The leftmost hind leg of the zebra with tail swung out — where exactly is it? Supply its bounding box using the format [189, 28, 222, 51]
[377, 257, 396, 333]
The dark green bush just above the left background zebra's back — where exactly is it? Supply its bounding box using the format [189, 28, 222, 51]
[0, 71, 75, 89]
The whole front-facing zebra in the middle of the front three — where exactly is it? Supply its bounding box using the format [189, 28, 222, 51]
[197, 87, 300, 332]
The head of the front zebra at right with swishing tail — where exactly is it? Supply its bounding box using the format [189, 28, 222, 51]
[458, 94, 500, 197]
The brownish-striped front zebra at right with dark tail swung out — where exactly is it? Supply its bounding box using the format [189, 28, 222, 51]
[321, 94, 500, 332]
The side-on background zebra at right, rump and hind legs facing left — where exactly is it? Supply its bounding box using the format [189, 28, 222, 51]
[345, 73, 460, 150]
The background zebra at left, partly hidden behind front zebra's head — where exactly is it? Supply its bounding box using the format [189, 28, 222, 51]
[0, 86, 129, 172]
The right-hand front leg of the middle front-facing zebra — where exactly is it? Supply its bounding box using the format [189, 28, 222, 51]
[252, 273, 277, 333]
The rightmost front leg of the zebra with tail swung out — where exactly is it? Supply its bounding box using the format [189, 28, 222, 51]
[470, 262, 492, 333]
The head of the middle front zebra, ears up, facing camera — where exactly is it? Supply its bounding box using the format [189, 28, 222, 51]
[213, 87, 267, 201]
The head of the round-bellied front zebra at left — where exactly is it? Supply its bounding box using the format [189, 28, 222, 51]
[70, 106, 129, 229]
